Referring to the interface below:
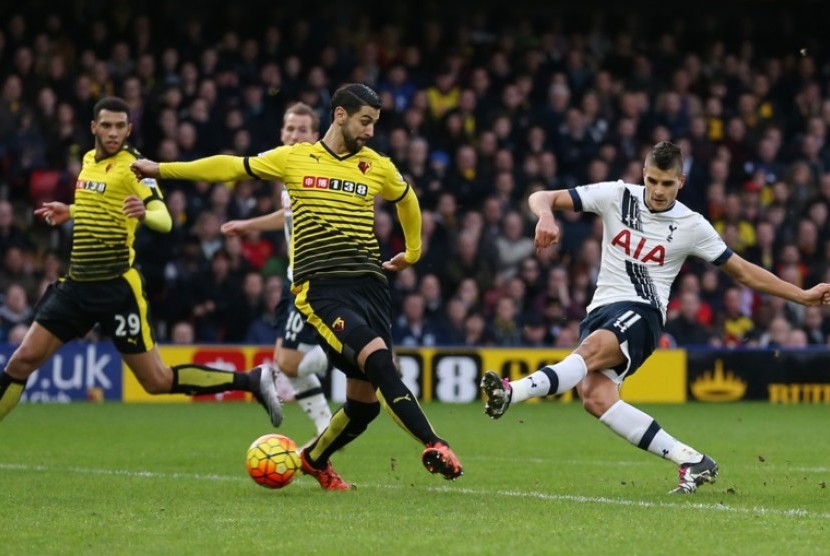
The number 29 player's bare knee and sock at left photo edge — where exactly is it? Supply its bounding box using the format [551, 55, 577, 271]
[0, 322, 63, 421]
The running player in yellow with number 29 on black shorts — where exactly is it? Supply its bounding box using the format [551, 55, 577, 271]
[0, 98, 282, 426]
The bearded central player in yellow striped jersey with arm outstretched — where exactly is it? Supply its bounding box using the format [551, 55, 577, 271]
[132, 83, 462, 490]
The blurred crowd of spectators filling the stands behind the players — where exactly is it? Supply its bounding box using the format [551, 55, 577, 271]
[0, 0, 830, 347]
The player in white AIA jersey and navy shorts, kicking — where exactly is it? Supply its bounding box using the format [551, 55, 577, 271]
[481, 141, 830, 493]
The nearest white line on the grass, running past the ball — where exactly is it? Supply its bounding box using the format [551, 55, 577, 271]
[0, 463, 830, 519]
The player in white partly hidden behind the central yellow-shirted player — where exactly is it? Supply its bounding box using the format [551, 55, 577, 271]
[222, 102, 338, 444]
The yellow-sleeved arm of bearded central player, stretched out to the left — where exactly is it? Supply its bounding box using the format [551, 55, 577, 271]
[130, 154, 251, 181]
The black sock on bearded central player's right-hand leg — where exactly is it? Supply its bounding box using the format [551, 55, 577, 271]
[365, 349, 446, 445]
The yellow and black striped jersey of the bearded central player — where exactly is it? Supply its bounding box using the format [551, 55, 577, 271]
[244, 141, 409, 283]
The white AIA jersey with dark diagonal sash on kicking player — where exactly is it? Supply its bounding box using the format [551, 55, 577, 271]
[570, 181, 732, 322]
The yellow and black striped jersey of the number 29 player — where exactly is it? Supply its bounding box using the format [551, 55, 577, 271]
[69, 146, 163, 281]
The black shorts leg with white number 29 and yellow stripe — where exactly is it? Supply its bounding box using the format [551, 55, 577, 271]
[98, 268, 156, 354]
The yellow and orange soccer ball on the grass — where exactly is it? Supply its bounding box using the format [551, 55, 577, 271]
[245, 434, 300, 488]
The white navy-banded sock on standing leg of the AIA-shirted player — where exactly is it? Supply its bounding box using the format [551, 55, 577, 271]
[599, 400, 703, 465]
